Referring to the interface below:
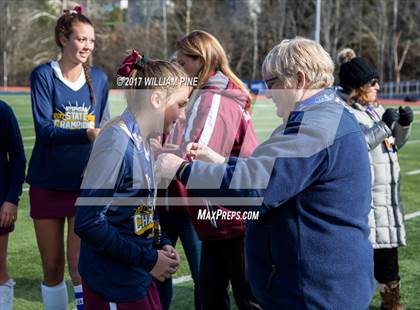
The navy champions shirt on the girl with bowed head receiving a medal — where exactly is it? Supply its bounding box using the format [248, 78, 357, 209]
[74, 111, 170, 303]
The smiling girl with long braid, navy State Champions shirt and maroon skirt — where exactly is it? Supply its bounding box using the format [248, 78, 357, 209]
[27, 7, 108, 310]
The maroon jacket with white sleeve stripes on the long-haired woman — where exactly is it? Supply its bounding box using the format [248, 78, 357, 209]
[165, 72, 258, 241]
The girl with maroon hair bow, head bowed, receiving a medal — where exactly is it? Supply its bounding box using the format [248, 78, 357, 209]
[75, 50, 191, 310]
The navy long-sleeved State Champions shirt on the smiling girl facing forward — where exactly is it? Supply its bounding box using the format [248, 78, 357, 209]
[27, 63, 109, 191]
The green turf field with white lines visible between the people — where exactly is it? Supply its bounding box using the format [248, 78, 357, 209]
[0, 95, 420, 310]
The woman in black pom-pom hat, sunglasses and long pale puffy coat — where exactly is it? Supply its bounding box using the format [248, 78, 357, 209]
[338, 49, 413, 310]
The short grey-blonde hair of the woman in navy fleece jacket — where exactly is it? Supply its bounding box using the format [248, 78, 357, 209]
[262, 37, 334, 88]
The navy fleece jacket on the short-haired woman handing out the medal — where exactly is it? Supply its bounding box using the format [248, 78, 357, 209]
[182, 90, 374, 310]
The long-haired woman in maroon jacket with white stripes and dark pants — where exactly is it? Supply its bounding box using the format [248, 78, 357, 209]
[173, 31, 259, 309]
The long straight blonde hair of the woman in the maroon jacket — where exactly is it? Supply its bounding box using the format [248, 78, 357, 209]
[176, 30, 249, 94]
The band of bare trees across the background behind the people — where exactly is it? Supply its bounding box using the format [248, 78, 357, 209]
[0, 0, 420, 85]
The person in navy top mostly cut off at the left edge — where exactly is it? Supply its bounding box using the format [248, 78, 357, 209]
[0, 100, 26, 310]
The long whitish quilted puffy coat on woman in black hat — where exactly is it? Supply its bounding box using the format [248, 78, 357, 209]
[351, 102, 410, 249]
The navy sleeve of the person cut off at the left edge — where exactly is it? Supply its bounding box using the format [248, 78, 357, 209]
[0, 100, 26, 207]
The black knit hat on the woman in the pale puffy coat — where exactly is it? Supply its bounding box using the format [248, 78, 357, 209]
[339, 57, 379, 92]
